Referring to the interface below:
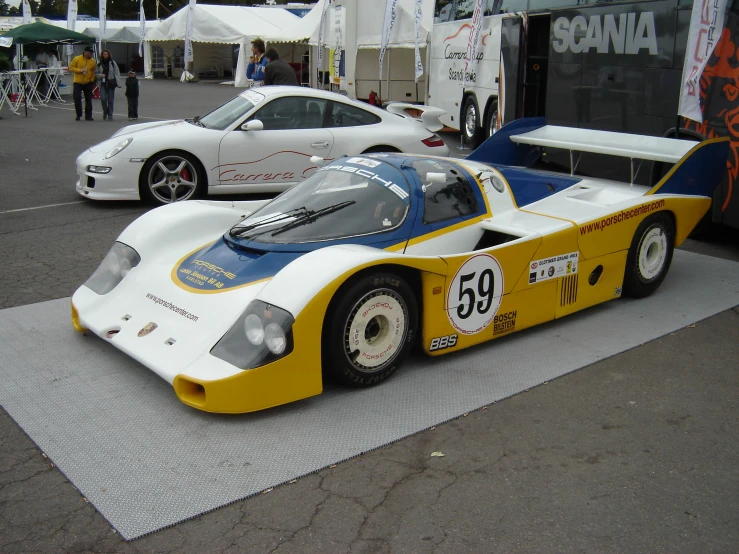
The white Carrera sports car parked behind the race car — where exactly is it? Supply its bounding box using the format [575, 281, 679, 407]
[77, 86, 449, 204]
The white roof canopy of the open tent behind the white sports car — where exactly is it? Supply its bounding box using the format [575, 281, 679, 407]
[144, 4, 301, 44]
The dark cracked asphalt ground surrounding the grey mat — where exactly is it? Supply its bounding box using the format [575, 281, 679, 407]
[0, 81, 739, 553]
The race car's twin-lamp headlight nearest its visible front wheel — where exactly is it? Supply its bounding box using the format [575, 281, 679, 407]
[210, 300, 295, 369]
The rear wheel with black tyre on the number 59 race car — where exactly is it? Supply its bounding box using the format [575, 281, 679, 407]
[622, 212, 675, 298]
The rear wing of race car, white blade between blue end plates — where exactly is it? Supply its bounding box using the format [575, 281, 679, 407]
[467, 117, 729, 196]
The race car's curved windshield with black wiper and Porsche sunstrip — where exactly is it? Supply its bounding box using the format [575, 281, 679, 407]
[230, 157, 410, 244]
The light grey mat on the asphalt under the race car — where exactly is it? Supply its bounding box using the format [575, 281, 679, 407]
[0, 251, 739, 540]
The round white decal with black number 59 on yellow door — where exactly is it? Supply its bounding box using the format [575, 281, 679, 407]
[447, 254, 503, 335]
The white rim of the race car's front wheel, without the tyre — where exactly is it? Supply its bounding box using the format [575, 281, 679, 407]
[344, 289, 408, 373]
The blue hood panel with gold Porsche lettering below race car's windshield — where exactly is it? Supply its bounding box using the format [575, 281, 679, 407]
[172, 238, 304, 292]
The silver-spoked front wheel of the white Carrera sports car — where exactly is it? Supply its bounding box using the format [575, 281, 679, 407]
[139, 150, 206, 204]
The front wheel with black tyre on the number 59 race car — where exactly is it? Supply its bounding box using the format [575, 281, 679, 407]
[323, 272, 418, 387]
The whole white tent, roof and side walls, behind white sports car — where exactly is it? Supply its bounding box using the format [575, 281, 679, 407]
[144, 4, 304, 86]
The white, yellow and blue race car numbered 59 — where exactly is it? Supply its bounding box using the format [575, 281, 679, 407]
[72, 119, 728, 413]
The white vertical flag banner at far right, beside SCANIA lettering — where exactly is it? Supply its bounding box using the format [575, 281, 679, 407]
[677, 0, 726, 123]
